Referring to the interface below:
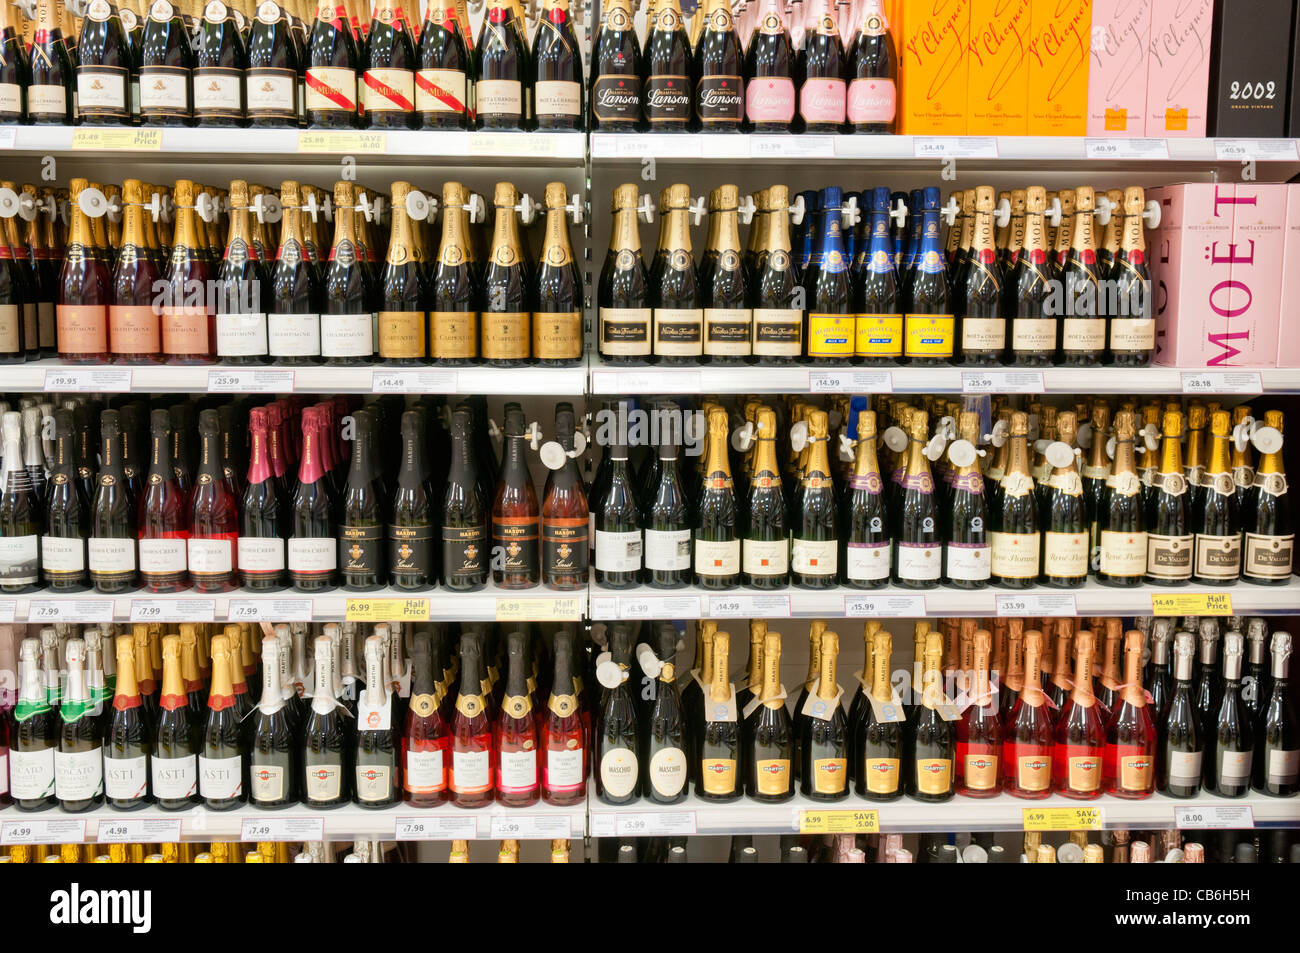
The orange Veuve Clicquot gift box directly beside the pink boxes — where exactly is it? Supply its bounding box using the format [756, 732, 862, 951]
[1028, 0, 1092, 135]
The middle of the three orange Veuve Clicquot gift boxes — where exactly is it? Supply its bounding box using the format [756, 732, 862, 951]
[966, 0, 1032, 135]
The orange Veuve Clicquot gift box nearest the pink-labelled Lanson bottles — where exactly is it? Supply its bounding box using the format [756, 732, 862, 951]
[897, 0, 971, 135]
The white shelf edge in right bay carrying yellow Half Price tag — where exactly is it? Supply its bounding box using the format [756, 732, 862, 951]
[590, 576, 1300, 620]
